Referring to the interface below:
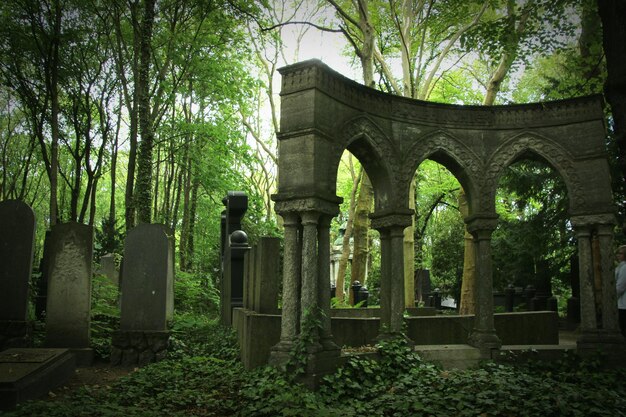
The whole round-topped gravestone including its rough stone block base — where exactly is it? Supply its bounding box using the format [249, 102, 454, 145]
[111, 224, 174, 366]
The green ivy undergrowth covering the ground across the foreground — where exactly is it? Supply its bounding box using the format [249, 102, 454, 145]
[0, 322, 626, 417]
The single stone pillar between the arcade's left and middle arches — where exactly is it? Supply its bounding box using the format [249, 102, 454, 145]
[371, 210, 413, 339]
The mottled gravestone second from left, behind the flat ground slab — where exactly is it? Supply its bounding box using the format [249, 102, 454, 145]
[45, 222, 93, 365]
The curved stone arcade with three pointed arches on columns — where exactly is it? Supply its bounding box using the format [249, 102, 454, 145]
[272, 60, 618, 370]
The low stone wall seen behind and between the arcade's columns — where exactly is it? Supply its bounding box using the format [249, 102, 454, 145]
[233, 308, 559, 369]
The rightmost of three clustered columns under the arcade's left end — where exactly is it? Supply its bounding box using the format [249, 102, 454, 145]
[317, 215, 340, 350]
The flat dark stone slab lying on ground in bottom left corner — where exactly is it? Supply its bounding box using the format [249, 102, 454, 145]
[0, 348, 76, 410]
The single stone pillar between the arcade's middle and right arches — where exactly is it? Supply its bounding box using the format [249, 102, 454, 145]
[466, 214, 502, 351]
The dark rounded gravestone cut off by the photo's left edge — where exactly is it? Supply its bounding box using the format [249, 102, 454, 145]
[0, 200, 35, 351]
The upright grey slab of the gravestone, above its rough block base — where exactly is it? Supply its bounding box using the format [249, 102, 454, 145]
[120, 224, 173, 330]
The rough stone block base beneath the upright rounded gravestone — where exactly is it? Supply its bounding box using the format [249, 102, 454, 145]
[111, 330, 170, 366]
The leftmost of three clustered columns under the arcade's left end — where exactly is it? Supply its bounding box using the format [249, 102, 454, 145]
[273, 213, 300, 351]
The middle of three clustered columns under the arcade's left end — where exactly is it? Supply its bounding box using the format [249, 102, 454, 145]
[300, 211, 322, 352]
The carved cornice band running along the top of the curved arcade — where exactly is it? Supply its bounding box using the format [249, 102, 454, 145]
[279, 60, 604, 129]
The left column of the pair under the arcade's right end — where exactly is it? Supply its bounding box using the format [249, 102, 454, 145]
[575, 226, 598, 333]
